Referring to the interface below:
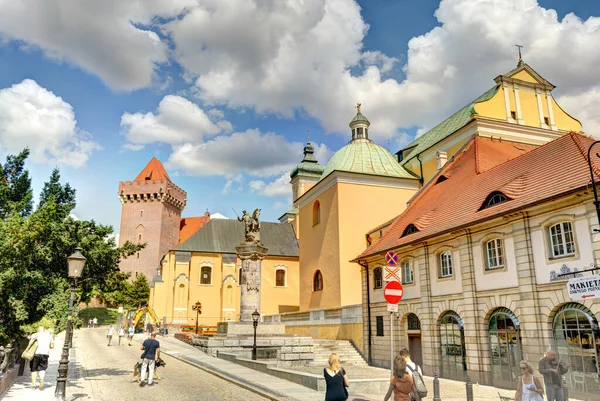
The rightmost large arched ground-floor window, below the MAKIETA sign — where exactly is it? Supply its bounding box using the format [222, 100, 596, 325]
[553, 302, 600, 392]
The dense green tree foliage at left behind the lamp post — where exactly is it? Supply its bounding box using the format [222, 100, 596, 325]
[0, 150, 142, 345]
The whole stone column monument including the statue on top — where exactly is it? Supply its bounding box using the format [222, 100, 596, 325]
[235, 209, 267, 323]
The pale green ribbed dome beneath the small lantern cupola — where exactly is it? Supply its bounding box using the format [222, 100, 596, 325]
[321, 139, 415, 179]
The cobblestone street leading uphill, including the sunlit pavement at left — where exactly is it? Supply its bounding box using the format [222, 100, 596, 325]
[2, 327, 264, 401]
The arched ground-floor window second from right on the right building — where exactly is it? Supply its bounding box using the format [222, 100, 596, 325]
[488, 308, 523, 386]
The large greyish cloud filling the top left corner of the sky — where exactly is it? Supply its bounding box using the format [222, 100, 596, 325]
[0, 0, 196, 90]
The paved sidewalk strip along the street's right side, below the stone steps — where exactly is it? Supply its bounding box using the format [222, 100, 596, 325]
[144, 334, 374, 401]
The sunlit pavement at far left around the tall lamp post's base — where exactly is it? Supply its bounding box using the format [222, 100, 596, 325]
[0, 330, 93, 401]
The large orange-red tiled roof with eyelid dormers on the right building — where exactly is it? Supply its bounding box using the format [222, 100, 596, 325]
[358, 132, 600, 258]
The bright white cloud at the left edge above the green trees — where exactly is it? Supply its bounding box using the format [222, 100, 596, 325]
[0, 79, 101, 167]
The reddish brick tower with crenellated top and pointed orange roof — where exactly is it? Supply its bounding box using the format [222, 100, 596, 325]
[119, 157, 187, 282]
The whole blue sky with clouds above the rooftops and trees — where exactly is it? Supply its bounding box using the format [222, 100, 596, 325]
[0, 0, 600, 232]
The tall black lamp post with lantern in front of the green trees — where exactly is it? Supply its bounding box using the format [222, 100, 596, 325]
[54, 248, 87, 400]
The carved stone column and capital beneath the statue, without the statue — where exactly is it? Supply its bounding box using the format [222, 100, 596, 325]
[235, 242, 267, 323]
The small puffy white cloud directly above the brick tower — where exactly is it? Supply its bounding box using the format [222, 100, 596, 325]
[121, 95, 227, 150]
